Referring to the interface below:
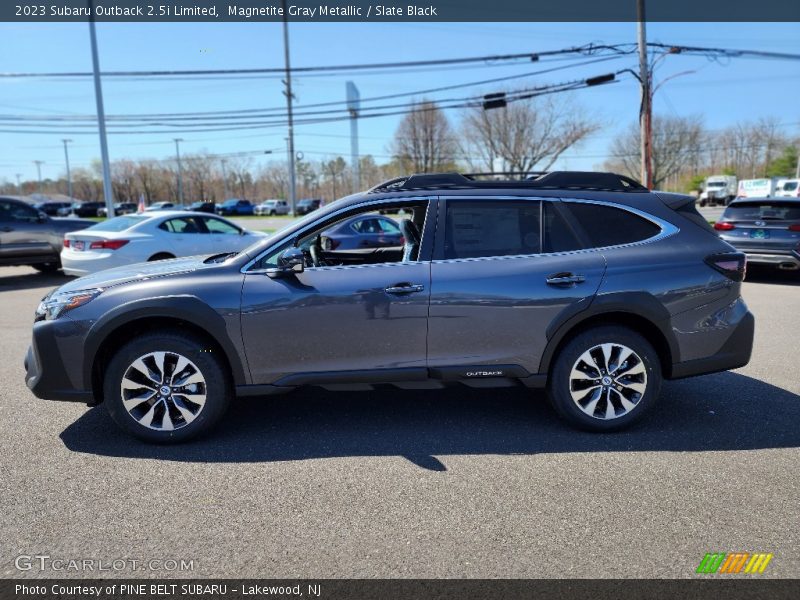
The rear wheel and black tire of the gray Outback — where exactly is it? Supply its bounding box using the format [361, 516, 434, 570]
[547, 325, 662, 432]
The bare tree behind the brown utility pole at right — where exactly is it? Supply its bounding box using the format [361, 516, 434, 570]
[606, 116, 705, 187]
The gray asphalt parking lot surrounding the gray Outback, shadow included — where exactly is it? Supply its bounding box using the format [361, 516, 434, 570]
[0, 268, 800, 578]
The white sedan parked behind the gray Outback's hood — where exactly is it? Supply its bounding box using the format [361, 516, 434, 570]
[61, 211, 267, 276]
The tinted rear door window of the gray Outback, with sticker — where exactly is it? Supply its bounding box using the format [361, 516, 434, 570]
[444, 200, 541, 259]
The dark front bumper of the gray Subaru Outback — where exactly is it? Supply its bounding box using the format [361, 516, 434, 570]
[25, 318, 94, 404]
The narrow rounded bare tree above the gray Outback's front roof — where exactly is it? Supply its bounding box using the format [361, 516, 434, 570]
[392, 100, 457, 173]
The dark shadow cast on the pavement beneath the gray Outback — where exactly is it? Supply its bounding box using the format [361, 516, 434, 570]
[61, 372, 800, 471]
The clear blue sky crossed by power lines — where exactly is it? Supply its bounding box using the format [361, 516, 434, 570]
[0, 23, 800, 181]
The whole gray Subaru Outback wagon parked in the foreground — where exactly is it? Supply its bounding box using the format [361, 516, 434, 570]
[25, 172, 754, 442]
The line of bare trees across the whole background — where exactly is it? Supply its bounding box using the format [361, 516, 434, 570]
[0, 96, 800, 204]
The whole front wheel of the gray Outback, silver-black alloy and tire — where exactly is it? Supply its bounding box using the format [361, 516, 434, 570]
[104, 332, 231, 442]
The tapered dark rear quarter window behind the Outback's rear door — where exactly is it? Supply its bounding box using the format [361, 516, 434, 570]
[564, 202, 661, 248]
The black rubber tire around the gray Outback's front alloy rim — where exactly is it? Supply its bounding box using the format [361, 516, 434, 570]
[103, 330, 233, 444]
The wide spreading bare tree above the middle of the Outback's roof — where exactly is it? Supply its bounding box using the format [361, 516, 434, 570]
[461, 98, 600, 174]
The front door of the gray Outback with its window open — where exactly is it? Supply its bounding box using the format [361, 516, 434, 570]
[241, 198, 431, 384]
